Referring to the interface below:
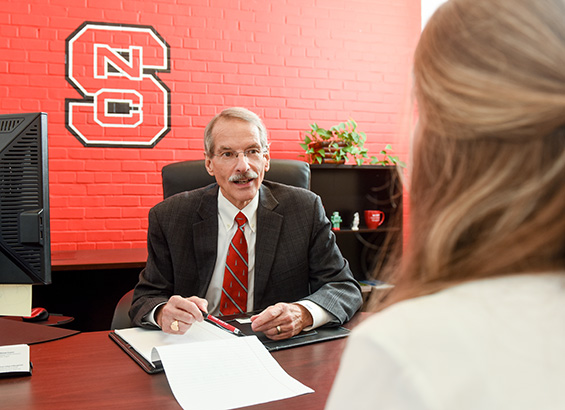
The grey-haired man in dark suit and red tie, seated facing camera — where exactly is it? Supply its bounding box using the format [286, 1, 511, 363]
[130, 108, 362, 340]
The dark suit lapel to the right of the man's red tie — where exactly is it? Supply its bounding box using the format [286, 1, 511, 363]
[254, 184, 284, 304]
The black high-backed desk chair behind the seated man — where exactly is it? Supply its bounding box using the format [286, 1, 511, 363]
[110, 159, 310, 330]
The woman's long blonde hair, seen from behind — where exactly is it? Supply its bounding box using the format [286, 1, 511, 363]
[374, 0, 565, 305]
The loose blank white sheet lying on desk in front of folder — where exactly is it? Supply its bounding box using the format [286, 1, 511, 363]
[156, 336, 314, 410]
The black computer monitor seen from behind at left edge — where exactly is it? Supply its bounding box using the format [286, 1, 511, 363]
[0, 113, 51, 285]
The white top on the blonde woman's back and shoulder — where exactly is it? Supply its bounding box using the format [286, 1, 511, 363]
[326, 272, 565, 410]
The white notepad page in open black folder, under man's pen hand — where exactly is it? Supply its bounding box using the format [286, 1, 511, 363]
[115, 322, 237, 363]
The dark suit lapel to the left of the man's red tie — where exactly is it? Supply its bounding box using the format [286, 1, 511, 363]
[192, 185, 218, 297]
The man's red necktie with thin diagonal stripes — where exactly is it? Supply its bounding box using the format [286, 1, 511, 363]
[220, 212, 247, 315]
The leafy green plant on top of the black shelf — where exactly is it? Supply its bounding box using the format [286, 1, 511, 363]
[300, 119, 405, 166]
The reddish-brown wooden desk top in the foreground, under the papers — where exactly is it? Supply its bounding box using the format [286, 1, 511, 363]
[0, 313, 369, 410]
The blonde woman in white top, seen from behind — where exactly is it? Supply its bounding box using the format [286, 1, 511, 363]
[327, 0, 565, 410]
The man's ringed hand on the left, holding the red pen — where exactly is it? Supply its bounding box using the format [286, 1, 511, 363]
[155, 295, 208, 335]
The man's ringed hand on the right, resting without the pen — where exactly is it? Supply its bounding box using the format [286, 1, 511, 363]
[251, 303, 313, 340]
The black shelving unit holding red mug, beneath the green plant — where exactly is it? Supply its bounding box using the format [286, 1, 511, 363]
[310, 164, 402, 280]
